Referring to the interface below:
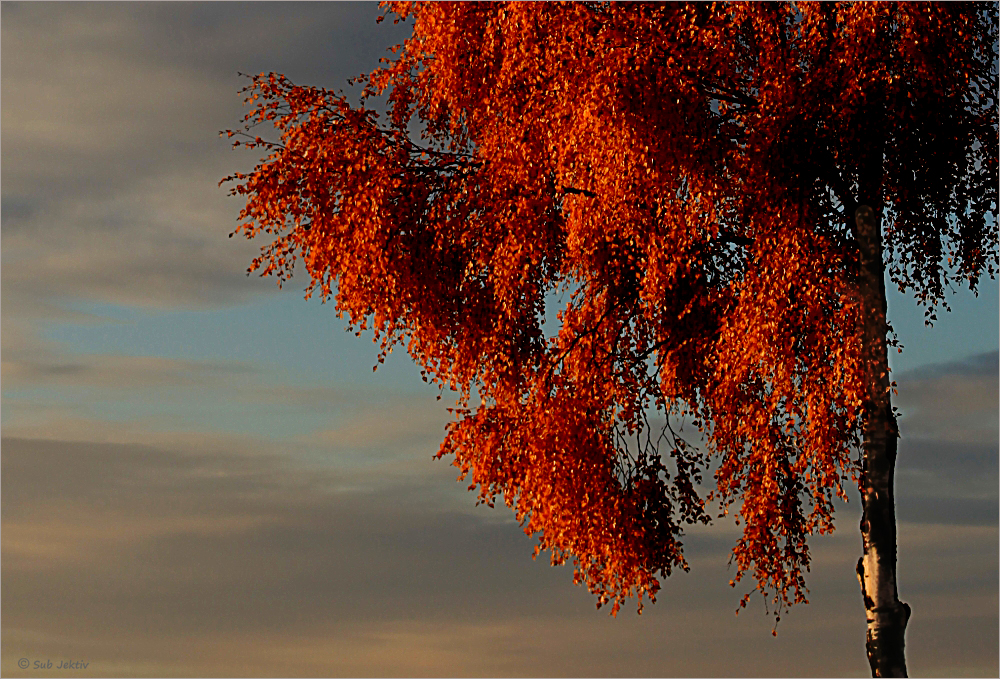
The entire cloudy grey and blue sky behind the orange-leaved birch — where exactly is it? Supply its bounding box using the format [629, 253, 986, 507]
[0, 2, 1000, 677]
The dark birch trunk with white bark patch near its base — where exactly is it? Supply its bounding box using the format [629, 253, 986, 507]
[854, 205, 910, 677]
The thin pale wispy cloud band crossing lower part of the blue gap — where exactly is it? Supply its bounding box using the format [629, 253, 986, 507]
[3, 346, 453, 476]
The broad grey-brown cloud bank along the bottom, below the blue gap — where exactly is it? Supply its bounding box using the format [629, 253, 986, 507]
[0, 438, 996, 676]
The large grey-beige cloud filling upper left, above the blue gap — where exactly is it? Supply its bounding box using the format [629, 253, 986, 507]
[2, 4, 403, 316]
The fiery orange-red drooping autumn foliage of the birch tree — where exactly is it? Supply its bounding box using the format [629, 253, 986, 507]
[223, 3, 997, 611]
